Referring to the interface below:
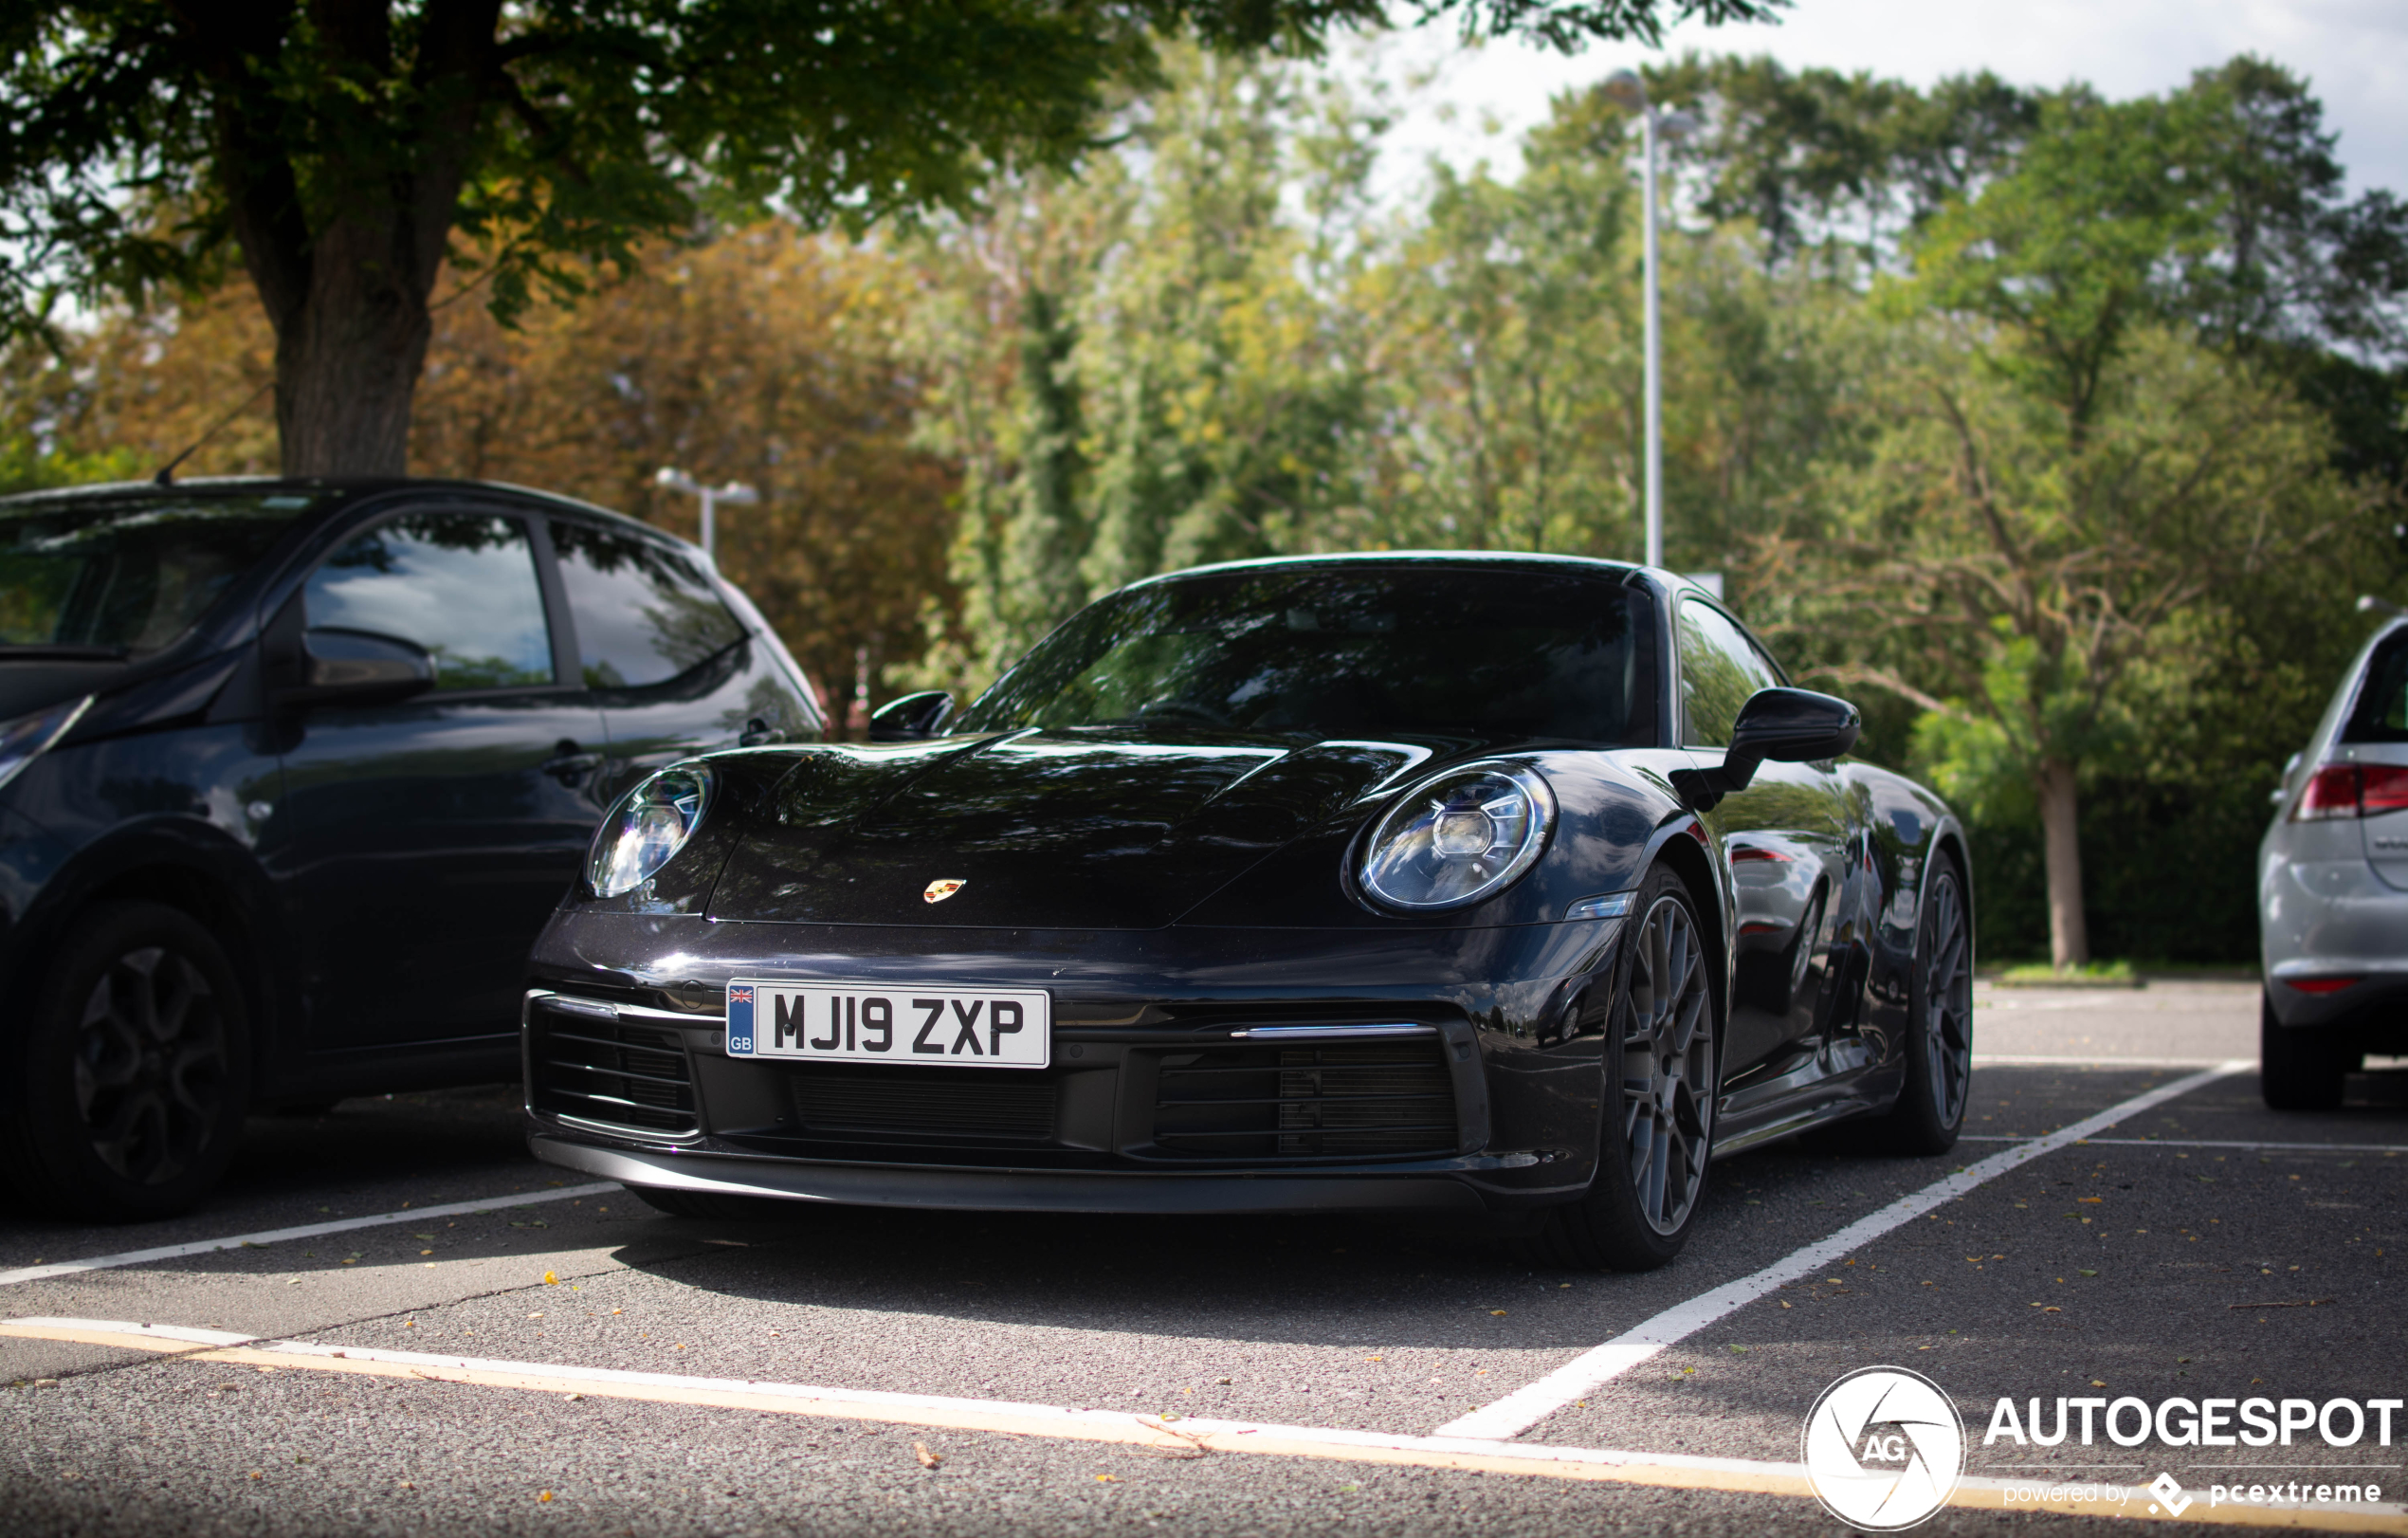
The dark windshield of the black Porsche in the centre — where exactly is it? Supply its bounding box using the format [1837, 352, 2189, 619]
[954, 563, 1651, 743]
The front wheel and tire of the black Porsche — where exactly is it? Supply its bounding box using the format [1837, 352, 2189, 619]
[1515, 867, 1722, 1271]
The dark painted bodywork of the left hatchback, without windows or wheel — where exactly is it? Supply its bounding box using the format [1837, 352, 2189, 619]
[0, 482, 821, 1103]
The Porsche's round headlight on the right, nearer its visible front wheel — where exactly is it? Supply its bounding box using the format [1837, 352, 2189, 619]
[1360, 763, 1556, 909]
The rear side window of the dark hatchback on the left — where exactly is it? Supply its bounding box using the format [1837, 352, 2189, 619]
[552, 520, 744, 688]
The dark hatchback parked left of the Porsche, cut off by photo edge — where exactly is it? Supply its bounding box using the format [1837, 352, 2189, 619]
[0, 482, 821, 1218]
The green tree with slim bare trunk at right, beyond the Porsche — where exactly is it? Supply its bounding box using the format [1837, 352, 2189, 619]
[1820, 322, 2362, 967]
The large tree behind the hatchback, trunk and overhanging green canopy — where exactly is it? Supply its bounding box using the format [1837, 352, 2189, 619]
[0, 0, 1778, 474]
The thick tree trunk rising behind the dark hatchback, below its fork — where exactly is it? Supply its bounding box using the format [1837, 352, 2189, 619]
[277, 222, 433, 477]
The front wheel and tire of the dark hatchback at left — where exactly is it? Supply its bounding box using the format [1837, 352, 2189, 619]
[0, 903, 250, 1222]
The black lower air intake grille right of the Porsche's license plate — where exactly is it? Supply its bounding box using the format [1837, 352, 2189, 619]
[1154, 1037, 1457, 1158]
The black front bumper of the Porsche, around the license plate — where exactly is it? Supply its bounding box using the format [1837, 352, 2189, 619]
[522, 912, 1618, 1213]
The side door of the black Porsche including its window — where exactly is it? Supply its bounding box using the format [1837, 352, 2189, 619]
[1673, 595, 1861, 1081]
